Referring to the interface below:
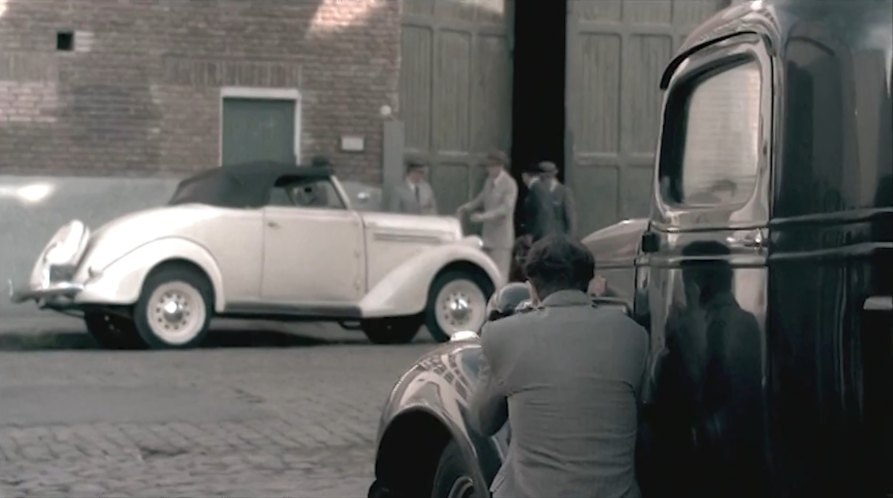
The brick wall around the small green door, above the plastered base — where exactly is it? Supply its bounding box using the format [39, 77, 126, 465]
[0, 0, 400, 183]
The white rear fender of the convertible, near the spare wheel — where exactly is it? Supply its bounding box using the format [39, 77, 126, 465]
[75, 237, 226, 312]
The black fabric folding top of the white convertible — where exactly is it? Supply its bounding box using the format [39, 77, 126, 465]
[168, 162, 332, 208]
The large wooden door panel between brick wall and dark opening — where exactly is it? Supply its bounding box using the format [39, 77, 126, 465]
[399, 0, 514, 214]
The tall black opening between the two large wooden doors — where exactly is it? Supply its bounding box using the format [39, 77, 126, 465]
[512, 0, 567, 224]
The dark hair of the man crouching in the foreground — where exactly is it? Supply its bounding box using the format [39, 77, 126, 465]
[524, 235, 595, 299]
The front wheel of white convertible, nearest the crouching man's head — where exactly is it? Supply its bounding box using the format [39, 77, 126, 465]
[425, 271, 493, 342]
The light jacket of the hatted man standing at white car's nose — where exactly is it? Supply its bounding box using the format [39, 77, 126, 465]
[467, 171, 518, 250]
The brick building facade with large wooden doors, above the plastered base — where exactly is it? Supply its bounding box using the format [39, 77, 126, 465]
[0, 0, 741, 233]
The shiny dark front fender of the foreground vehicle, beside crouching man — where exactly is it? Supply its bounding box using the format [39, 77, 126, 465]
[376, 340, 508, 489]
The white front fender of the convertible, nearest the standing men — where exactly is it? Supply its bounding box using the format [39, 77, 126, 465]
[360, 237, 503, 318]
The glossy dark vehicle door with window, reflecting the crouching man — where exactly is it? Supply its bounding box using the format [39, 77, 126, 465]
[637, 35, 773, 496]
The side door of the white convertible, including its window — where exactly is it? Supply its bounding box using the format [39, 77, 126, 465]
[261, 176, 365, 312]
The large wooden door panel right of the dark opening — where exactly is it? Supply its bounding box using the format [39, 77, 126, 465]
[565, 0, 730, 236]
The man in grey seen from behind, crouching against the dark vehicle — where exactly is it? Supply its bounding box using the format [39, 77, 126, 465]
[471, 235, 648, 498]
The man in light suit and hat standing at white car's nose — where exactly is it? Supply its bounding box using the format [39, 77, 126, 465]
[457, 151, 518, 278]
